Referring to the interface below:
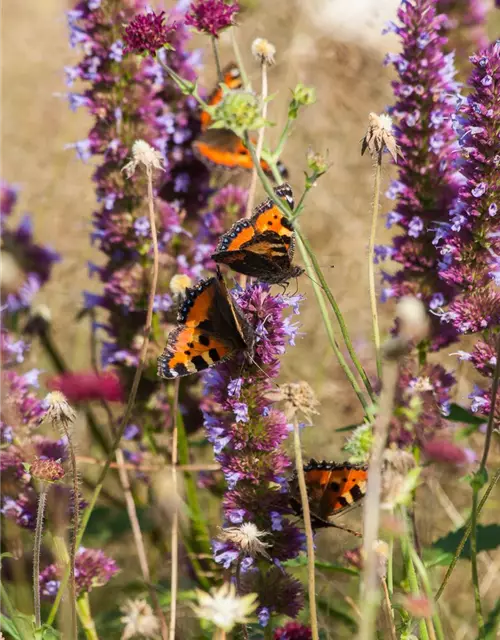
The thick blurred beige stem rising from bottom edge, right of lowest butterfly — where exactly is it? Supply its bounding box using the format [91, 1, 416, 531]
[358, 359, 399, 640]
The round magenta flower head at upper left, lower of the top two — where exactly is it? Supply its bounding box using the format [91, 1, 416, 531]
[123, 11, 179, 58]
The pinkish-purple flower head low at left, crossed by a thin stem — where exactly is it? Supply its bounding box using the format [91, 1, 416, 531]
[40, 547, 119, 599]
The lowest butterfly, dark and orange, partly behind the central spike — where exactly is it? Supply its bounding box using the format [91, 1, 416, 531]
[289, 459, 368, 536]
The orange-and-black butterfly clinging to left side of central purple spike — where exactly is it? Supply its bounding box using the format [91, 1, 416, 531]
[158, 270, 255, 378]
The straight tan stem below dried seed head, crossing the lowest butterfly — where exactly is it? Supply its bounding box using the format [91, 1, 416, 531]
[293, 418, 319, 640]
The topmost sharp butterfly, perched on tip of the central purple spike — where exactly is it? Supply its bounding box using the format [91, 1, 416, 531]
[212, 183, 304, 284]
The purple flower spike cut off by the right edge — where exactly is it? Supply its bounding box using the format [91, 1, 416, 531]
[436, 41, 500, 414]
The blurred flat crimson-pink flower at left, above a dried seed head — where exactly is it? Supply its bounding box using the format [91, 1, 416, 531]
[48, 372, 124, 402]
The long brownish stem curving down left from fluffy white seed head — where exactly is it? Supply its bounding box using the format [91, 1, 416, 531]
[47, 161, 159, 624]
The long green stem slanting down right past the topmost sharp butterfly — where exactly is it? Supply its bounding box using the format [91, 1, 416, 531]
[245, 135, 375, 400]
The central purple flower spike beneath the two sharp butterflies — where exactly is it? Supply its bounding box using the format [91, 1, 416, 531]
[204, 284, 304, 621]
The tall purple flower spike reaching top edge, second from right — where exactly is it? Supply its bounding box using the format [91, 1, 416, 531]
[378, 0, 458, 349]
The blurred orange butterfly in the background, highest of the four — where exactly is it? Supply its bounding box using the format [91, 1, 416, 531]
[193, 63, 288, 177]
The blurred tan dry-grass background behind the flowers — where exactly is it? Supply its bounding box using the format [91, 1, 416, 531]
[0, 0, 500, 638]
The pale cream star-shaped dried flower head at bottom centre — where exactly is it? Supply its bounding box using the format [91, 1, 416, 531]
[193, 582, 257, 631]
